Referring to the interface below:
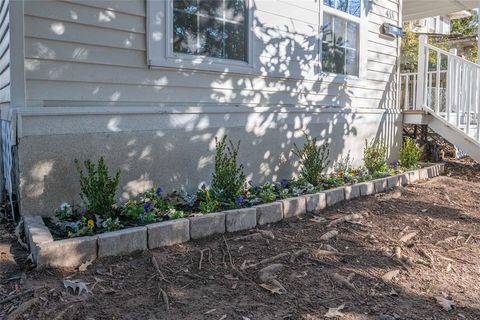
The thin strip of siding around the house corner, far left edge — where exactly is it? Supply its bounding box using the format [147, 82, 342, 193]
[0, 0, 10, 104]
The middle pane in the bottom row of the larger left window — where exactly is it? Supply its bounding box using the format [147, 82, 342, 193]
[198, 17, 225, 58]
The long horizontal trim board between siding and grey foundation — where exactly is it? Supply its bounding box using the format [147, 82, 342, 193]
[17, 106, 402, 139]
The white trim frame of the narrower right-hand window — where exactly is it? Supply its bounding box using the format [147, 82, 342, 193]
[318, 0, 370, 81]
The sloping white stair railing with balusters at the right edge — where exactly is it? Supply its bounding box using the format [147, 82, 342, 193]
[413, 36, 480, 141]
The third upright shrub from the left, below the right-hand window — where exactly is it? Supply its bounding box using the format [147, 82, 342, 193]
[293, 132, 330, 186]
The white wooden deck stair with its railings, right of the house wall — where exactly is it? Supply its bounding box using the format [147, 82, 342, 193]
[401, 36, 480, 161]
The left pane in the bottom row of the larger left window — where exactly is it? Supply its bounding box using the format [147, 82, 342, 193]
[173, 12, 197, 54]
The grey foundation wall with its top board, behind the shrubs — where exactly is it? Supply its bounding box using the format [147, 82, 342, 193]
[16, 107, 402, 216]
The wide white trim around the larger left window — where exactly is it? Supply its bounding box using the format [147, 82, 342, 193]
[147, 0, 254, 74]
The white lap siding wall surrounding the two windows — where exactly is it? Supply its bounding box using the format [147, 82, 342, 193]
[21, 0, 398, 108]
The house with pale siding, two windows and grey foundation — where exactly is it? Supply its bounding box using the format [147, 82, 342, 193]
[0, 0, 478, 215]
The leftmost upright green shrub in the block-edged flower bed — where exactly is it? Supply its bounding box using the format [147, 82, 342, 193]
[75, 157, 120, 218]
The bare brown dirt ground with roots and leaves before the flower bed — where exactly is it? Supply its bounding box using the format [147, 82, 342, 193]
[0, 162, 480, 320]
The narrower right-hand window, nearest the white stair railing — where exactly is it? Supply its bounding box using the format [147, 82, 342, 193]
[322, 0, 361, 76]
